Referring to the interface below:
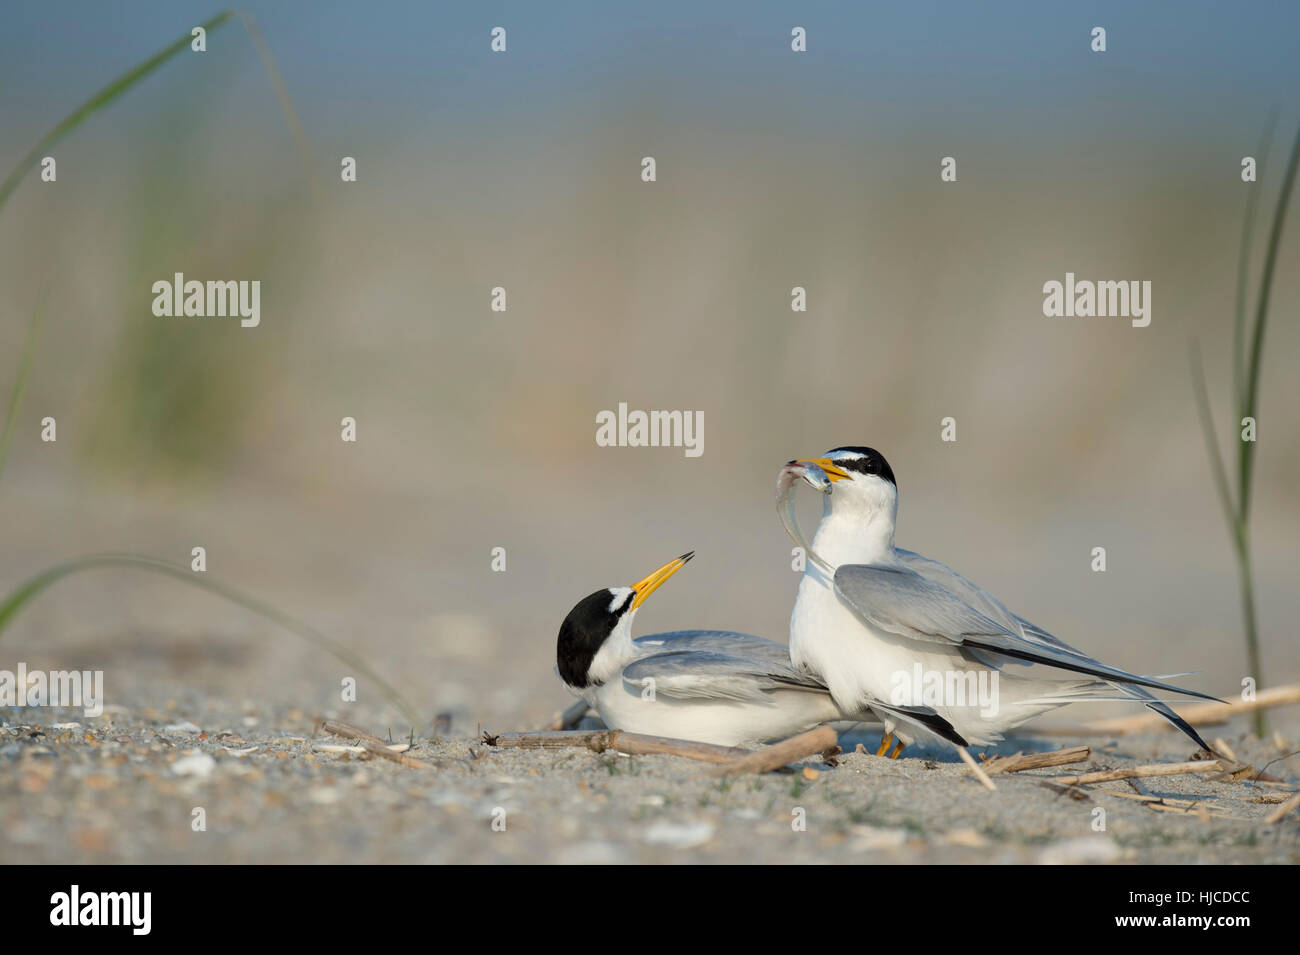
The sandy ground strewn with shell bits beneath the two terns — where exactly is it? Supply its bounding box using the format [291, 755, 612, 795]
[0, 687, 1300, 864]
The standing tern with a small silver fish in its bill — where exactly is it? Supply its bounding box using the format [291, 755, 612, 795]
[777, 447, 1214, 756]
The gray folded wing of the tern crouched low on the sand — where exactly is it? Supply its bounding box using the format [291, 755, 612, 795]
[623, 630, 827, 702]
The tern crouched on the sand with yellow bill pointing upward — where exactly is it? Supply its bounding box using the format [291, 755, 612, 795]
[555, 551, 861, 746]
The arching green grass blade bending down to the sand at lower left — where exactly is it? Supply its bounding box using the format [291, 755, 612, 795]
[0, 554, 424, 728]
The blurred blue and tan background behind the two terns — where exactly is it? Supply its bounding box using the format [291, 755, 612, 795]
[0, 0, 1300, 732]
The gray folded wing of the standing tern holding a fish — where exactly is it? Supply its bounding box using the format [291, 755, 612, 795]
[835, 561, 1214, 699]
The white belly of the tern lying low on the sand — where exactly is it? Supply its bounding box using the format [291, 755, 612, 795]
[594, 680, 840, 746]
